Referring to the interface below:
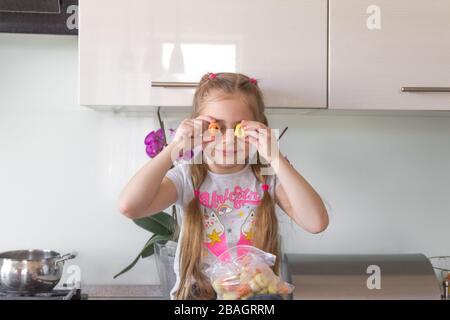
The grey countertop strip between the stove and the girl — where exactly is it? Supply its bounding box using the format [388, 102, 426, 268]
[81, 284, 165, 300]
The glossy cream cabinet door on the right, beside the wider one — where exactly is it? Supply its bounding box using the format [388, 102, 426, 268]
[329, 0, 450, 110]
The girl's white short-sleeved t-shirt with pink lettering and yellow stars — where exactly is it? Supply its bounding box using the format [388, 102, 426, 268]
[166, 163, 279, 300]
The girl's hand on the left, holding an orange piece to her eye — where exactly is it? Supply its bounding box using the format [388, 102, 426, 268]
[173, 115, 216, 152]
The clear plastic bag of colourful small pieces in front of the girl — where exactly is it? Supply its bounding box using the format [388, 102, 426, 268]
[205, 245, 294, 300]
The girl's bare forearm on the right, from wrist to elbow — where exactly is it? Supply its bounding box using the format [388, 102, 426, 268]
[271, 153, 328, 233]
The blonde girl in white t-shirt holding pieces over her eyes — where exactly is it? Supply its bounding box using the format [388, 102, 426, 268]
[119, 73, 328, 299]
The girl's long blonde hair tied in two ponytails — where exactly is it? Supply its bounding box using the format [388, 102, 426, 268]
[175, 73, 281, 300]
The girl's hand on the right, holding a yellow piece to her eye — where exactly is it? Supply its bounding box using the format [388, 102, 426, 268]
[241, 120, 280, 163]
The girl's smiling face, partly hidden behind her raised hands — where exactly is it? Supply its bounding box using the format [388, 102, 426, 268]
[200, 92, 256, 169]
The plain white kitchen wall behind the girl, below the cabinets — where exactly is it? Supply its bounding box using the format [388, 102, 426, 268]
[0, 34, 450, 284]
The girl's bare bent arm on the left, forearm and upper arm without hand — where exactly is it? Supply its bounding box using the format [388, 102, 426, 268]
[119, 143, 177, 219]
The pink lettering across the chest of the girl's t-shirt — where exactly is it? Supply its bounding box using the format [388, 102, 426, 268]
[199, 186, 261, 209]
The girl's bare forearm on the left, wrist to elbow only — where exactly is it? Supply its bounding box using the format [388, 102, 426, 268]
[119, 143, 176, 212]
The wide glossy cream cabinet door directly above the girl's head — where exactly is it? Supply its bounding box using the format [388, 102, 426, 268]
[79, 0, 327, 108]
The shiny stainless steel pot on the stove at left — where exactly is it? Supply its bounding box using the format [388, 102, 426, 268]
[0, 250, 77, 293]
